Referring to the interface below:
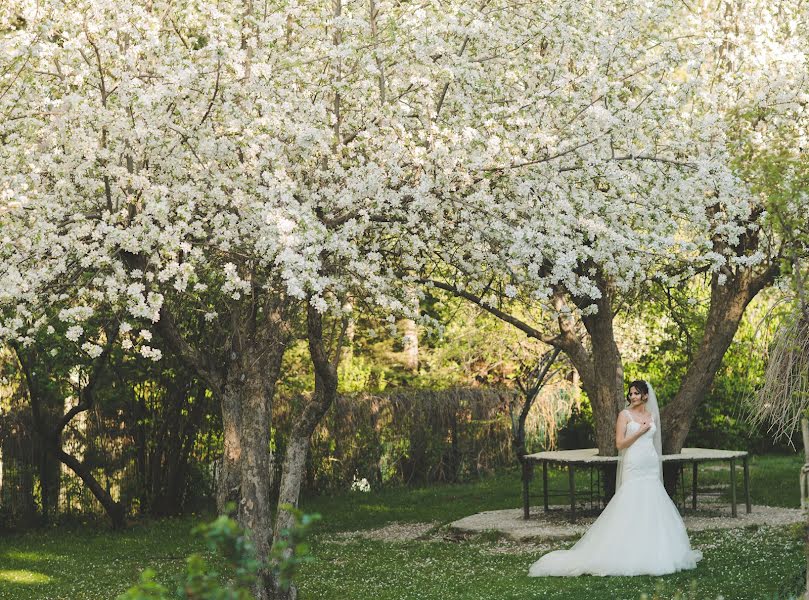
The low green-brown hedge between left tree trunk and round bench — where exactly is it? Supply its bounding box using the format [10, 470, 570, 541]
[308, 388, 514, 492]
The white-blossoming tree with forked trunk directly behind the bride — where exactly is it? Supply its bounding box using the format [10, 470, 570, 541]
[425, 3, 807, 474]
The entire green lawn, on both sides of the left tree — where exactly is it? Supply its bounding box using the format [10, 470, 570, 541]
[0, 456, 804, 600]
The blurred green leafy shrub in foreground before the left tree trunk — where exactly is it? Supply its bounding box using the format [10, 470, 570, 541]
[118, 505, 320, 600]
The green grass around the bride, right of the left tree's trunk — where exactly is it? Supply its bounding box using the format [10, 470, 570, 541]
[299, 455, 804, 600]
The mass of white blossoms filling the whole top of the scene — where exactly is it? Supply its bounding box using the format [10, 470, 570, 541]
[0, 0, 808, 352]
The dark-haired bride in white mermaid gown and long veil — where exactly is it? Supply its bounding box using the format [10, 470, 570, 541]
[528, 381, 702, 577]
